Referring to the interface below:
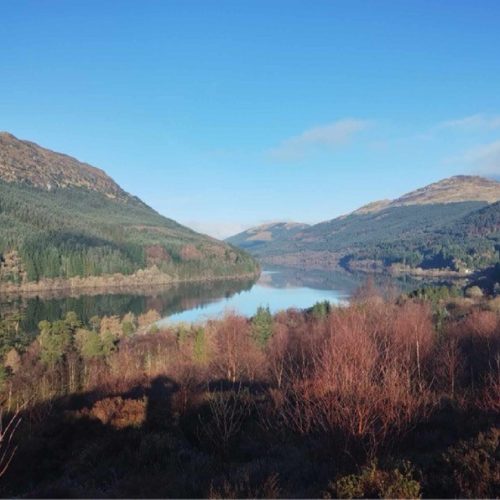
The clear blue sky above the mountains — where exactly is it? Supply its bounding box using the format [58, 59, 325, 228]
[0, 0, 500, 237]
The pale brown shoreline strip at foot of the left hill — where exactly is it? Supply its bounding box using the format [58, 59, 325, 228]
[0, 268, 262, 297]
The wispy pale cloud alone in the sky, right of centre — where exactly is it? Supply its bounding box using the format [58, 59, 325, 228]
[269, 118, 372, 161]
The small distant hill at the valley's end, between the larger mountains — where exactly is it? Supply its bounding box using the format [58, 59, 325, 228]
[226, 222, 309, 251]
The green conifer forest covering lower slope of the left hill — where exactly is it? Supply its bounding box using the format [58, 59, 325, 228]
[0, 182, 257, 283]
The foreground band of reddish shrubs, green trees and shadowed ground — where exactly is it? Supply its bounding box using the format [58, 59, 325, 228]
[0, 288, 500, 498]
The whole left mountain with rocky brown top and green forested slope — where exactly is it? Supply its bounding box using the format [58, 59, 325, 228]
[0, 133, 258, 289]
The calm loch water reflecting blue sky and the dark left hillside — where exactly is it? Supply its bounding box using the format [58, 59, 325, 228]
[0, 268, 426, 335]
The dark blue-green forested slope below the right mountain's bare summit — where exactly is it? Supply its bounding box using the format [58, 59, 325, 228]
[258, 202, 500, 271]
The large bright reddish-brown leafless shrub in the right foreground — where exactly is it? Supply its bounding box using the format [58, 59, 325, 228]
[279, 302, 433, 445]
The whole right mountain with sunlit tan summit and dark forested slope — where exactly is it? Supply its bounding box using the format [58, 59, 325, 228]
[230, 176, 500, 273]
